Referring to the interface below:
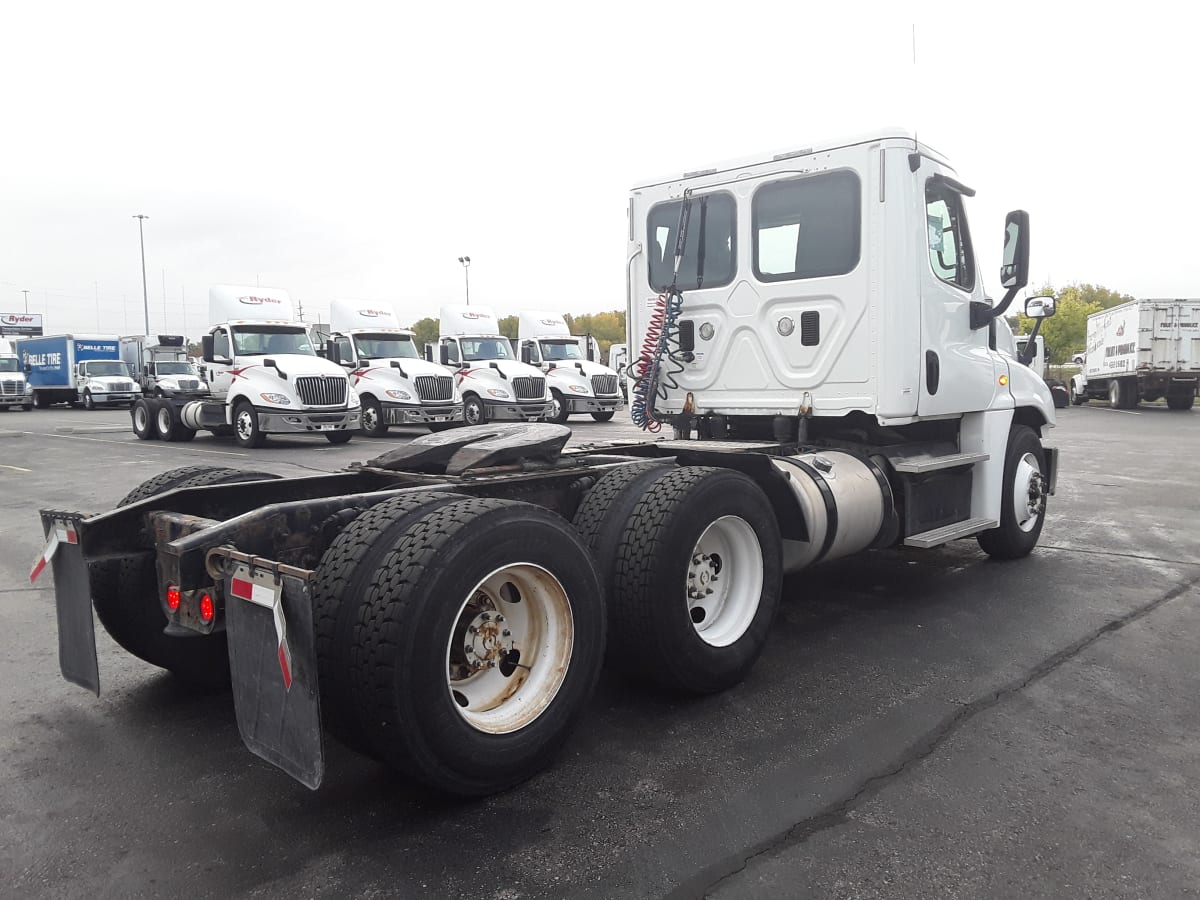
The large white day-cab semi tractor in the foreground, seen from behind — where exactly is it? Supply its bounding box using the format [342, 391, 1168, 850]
[35, 130, 1057, 796]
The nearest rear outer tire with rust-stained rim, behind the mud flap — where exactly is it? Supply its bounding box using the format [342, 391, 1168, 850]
[353, 499, 605, 797]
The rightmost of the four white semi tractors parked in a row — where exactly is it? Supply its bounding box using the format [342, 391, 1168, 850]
[517, 310, 623, 422]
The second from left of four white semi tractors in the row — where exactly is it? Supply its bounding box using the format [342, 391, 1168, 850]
[326, 300, 462, 437]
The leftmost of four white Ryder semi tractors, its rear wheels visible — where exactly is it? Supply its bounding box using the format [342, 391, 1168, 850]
[132, 284, 360, 448]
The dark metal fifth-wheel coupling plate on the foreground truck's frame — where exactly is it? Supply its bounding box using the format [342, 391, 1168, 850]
[365, 422, 571, 475]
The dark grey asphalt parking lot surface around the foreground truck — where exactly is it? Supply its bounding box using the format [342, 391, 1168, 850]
[0, 403, 1200, 900]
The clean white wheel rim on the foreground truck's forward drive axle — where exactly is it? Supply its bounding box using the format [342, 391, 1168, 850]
[686, 516, 762, 647]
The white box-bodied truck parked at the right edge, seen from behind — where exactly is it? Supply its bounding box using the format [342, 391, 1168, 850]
[1070, 299, 1200, 409]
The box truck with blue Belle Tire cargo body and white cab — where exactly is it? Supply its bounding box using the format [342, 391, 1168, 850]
[17, 335, 142, 409]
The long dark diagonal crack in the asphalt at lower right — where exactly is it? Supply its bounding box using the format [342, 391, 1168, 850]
[666, 573, 1200, 900]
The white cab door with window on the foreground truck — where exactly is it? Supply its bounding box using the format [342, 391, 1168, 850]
[916, 170, 1000, 416]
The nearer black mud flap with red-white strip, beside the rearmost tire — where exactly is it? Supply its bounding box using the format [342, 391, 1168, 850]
[224, 563, 325, 791]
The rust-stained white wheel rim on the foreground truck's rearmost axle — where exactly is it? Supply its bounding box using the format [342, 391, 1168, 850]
[445, 563, 575, 734]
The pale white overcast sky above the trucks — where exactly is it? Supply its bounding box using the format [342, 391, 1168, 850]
[0, 0, 1200, 337]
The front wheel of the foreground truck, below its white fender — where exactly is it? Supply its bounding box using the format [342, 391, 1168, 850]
[977, 425, 1050, 559]
